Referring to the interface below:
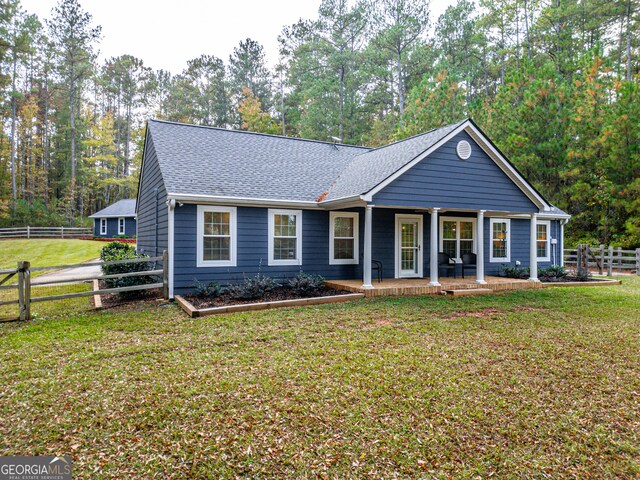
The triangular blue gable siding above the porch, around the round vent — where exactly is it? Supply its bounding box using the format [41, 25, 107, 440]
[373, 132, 538, 212]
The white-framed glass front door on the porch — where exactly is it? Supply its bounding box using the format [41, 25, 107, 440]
[396, 215, 422, 278]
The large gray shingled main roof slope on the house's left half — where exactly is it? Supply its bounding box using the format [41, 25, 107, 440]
[147, 120, 369, 201]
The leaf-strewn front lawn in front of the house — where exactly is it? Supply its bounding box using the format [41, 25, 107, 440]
[0, 277, 640, 478]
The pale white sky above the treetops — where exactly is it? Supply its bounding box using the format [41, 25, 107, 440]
[21, 0, 454, 74]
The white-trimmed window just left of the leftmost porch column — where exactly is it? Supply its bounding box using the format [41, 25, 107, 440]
[329, 212, 359, 265]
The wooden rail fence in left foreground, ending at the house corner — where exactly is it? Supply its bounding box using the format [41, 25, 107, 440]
[0, 250, 169, 321]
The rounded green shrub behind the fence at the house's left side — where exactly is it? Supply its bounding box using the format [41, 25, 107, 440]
[100, 242, 154, 297]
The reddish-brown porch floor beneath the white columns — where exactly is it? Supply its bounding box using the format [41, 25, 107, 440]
[325, 276, 543, 297]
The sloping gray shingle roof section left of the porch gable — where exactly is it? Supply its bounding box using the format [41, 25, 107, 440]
[326, 120, 466, 200]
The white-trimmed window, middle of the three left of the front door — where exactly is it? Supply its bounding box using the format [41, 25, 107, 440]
[269, 209, 302, 265]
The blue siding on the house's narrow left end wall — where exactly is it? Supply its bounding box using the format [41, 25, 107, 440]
[137, 132, 169, 256]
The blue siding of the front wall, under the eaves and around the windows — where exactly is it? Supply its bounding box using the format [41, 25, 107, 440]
[174, 204, 559, 294]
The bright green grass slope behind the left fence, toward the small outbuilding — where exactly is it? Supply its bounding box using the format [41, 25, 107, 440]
[0, 239, 105, 269]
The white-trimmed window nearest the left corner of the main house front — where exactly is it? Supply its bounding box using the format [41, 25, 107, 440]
[197, 205, 237, 267]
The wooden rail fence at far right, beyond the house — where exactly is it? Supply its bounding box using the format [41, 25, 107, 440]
[564, 245, 640, 276]
